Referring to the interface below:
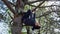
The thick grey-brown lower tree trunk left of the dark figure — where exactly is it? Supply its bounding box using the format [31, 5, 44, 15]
[11, 16, 22, 34]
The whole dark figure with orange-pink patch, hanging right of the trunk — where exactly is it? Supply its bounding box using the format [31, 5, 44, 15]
[22, 9, 40, 30]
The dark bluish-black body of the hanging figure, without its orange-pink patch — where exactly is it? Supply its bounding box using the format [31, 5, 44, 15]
[22, 9, 35, 26]
